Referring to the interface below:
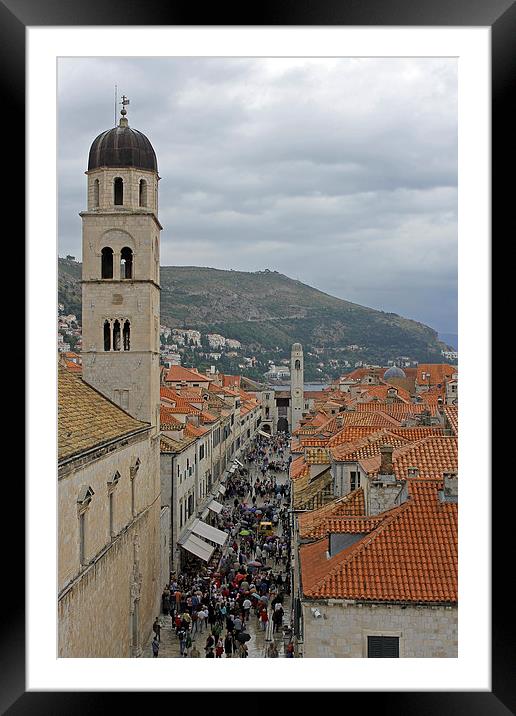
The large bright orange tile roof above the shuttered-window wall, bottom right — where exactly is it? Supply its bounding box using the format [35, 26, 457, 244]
[299, 480, 458, 604]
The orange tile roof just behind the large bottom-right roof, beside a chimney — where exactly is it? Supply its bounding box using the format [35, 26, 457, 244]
[360, 435, 458, 479]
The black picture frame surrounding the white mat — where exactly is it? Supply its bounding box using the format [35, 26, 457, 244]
[8, 0, 508, 716]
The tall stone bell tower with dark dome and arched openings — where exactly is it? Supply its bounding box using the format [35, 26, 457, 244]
[80, 96, 162, 434]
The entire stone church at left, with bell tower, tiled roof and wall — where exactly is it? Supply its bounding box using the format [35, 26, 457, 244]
[58, 103, 163, 657]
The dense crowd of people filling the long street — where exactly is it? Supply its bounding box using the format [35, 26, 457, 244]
[152, 434, 294, 658]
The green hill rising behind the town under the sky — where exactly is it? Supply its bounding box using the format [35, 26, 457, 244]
[59, 259, 450, 377]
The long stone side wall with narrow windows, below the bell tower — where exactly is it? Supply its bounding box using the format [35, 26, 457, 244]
[58, 431, 163, 657]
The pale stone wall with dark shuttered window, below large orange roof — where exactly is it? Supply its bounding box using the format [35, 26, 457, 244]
[302, 600, 458, 658]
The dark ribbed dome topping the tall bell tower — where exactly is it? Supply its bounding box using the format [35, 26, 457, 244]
[88, 117, 158, 172]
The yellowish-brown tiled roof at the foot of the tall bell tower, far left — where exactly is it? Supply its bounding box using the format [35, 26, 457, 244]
[58, 365, 149, 461]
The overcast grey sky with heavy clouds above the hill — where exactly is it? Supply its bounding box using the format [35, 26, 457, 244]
[58, 58, 457, 333]
